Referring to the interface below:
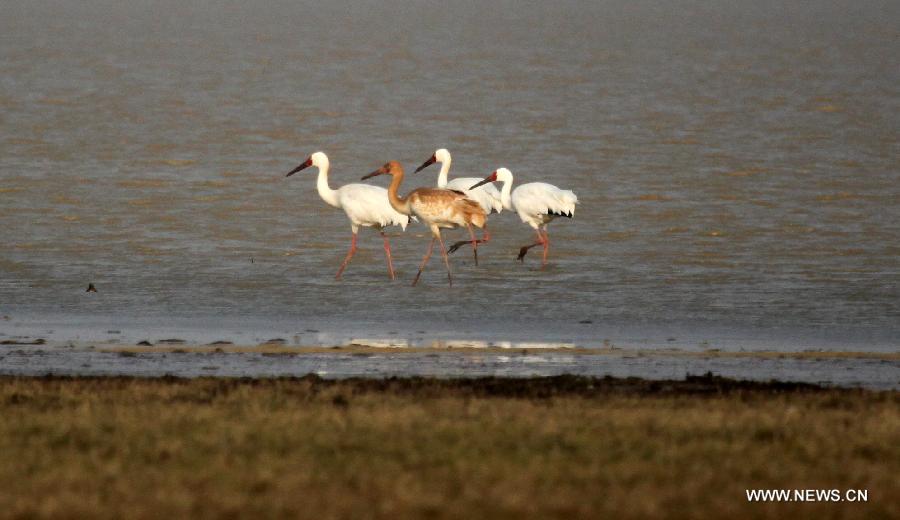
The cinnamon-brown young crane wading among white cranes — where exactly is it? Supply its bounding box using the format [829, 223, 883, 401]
[363, 161, 485, 287]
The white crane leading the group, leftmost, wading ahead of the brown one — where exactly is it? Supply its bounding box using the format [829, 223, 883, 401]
[287, 152, 409, 280]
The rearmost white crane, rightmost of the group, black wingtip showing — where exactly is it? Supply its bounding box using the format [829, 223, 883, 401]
[464, 168, 578, 268]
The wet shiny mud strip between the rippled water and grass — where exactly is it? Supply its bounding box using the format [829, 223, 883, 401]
[0, 343, 900, 389]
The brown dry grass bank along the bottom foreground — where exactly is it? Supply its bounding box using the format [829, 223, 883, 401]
[0, 376, 900, 519]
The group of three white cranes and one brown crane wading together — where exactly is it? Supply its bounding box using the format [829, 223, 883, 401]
[287, 148, 578, 286]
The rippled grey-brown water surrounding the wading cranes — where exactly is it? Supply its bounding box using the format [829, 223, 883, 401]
[0, 0, 900, 350]
